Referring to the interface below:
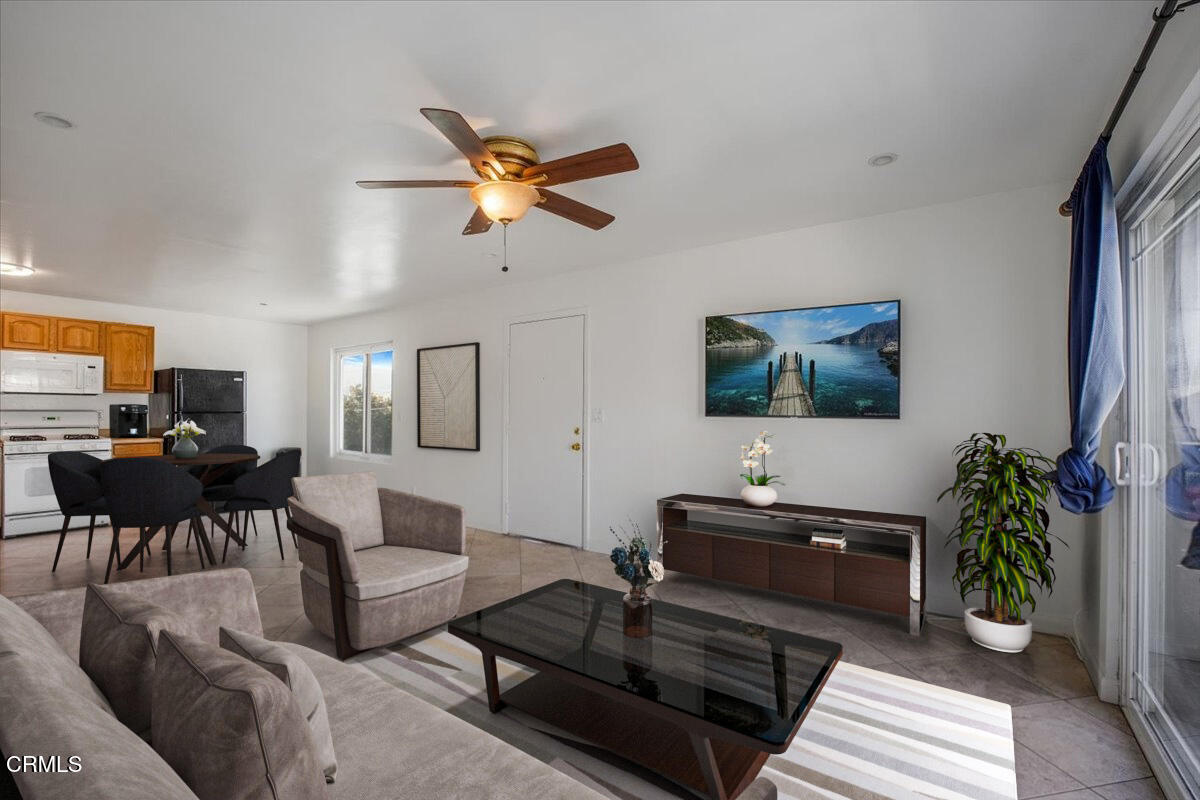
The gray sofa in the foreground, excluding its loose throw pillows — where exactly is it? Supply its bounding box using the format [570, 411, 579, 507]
[0, 569, 602, 800]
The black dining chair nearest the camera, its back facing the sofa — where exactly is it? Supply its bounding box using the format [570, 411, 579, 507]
[100, 458, 204, 583]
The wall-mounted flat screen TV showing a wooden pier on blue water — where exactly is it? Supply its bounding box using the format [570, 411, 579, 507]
[704, 300, 900, 420]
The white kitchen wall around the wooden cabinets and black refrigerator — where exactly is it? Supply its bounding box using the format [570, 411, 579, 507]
[0, 291, 308, 456]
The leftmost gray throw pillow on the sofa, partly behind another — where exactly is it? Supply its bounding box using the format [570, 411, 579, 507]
[79, 584, 187, 735]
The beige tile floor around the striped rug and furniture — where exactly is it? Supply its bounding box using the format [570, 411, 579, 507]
[0, 512, 1163, 800]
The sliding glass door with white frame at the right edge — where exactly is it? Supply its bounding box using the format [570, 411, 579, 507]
[1118, 133, 1200, 796]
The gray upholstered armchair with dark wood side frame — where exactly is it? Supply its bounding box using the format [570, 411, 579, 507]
[288, 473, 467, 658]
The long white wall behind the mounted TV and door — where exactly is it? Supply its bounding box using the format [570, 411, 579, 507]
[308, 185, 1099, 632]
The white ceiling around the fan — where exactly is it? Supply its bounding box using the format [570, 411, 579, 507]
[0, 0, 1154, 321]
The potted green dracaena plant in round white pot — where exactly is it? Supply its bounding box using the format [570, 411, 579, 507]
[937, 433, 1062, 652]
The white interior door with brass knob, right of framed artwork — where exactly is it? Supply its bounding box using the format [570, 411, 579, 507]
[506, 315, 587, 547]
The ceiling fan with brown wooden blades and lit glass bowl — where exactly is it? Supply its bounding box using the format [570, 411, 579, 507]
[358, 108, 637, 253]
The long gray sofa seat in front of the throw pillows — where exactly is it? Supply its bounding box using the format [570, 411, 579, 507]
[280, 642, 601, 800]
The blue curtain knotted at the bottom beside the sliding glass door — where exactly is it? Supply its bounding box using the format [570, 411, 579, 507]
[1054, 139, 1124, 513]
